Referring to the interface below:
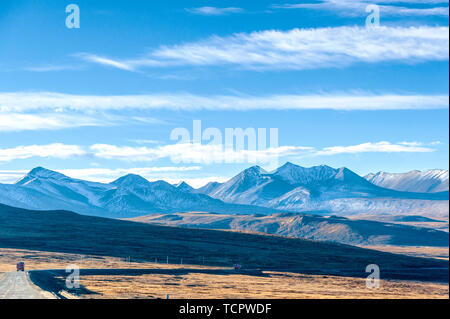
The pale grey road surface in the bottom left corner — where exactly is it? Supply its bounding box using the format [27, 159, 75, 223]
[0, 271, 51, 299]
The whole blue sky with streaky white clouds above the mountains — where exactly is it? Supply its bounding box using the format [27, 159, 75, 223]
[0, 0, 449, 186]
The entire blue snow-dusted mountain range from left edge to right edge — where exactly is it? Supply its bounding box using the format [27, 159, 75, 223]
[0, 163, 449, 219]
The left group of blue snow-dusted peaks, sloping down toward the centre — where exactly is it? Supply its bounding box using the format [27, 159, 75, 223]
[0, 167, 273, 217]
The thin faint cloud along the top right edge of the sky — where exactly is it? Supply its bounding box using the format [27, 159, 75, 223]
[273, 0, 449, 17]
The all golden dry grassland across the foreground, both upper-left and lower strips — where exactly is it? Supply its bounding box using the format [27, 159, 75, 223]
[0, 248, 449, 299]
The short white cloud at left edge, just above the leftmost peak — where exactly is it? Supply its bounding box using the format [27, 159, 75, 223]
[0, 143, 86, 162]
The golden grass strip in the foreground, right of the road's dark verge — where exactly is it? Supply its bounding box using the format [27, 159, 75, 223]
[75, 272, 449, 299]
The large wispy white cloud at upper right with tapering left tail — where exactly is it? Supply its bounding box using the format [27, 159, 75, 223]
[75, 26, 449, 70]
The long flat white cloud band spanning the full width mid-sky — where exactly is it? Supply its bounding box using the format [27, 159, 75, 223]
[0, 91, 449, 132]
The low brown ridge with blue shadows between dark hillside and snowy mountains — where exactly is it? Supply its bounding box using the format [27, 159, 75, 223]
[127, 212, 449, 247]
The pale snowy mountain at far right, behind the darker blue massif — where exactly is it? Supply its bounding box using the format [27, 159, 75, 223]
[364, 169, 449, 193]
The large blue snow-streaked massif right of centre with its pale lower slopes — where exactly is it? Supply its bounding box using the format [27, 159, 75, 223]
[198, 163, 448, 216]
